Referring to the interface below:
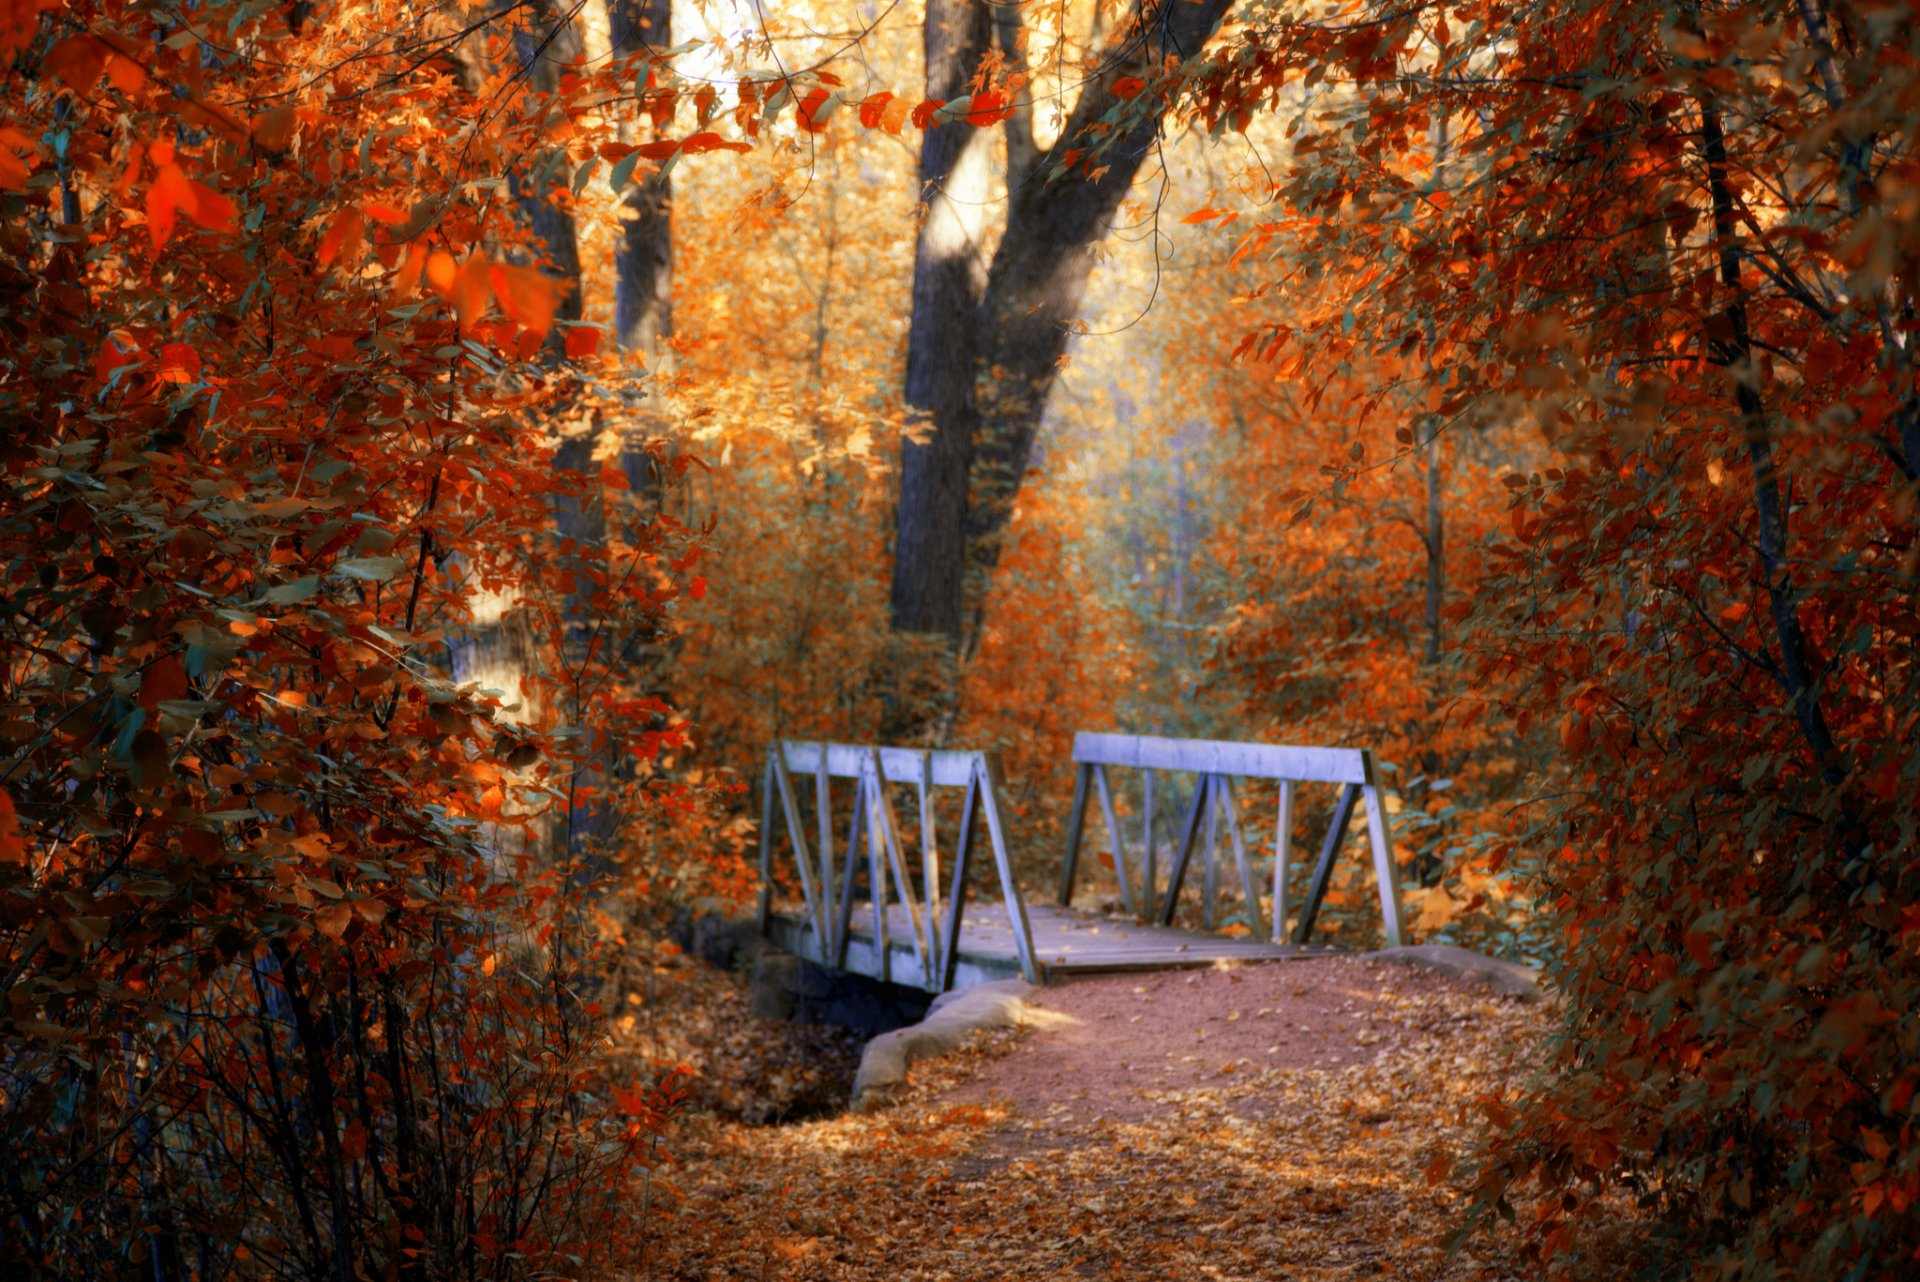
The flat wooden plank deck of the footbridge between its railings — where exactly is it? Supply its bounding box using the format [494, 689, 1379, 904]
[768, 902, 1331, 988]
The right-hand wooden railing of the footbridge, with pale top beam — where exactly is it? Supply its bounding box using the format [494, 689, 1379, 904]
[1060, 733, 1402, 946]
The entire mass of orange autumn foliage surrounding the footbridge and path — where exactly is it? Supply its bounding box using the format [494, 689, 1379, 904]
[11, 0, 1920, 1282]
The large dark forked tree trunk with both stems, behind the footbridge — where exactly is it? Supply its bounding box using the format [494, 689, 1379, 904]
[893, 0, 1231, 637]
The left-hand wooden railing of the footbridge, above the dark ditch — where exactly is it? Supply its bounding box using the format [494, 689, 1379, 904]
[760, 739, 1039, 992]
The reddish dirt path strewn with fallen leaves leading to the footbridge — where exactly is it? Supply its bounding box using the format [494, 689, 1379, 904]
[633, 958, 1605, 1282]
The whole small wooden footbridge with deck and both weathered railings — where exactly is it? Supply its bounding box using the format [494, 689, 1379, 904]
[760, 733, 1402, 992]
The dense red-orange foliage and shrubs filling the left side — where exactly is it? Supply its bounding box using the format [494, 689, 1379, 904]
[0, 2, 706, 1278]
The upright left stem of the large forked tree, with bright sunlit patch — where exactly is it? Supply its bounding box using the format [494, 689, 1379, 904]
[893, 0, 993, 639]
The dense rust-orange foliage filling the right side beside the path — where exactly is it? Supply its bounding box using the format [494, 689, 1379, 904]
[1194, 4, 1920, 1278]
